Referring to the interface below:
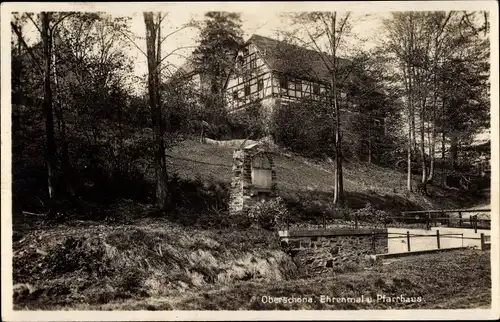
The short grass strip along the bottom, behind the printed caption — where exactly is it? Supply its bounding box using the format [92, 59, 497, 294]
[17, 250, 491, 310]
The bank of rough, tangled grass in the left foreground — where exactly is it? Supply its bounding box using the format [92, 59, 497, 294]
[13, 221, 297, 308]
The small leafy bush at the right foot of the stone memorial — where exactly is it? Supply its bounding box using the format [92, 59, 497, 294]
[248, 197, 289, 230]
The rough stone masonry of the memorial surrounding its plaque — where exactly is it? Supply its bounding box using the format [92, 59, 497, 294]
[229, 144, 277, 215]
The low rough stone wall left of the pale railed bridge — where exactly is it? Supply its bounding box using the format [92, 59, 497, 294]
[281, 229, 388, 273]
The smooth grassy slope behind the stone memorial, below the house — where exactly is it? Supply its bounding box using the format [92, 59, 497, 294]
[169, 141, 475, 212]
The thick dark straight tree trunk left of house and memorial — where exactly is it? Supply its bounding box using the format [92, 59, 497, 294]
[144, 12, 169, 210]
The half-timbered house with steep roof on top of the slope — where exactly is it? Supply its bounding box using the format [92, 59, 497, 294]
[225, 35, 338, 111]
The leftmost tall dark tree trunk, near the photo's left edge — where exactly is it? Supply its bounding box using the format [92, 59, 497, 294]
[41, 12, 56, 199]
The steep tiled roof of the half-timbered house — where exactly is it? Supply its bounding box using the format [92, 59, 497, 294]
[247, 34, 347, 82]
